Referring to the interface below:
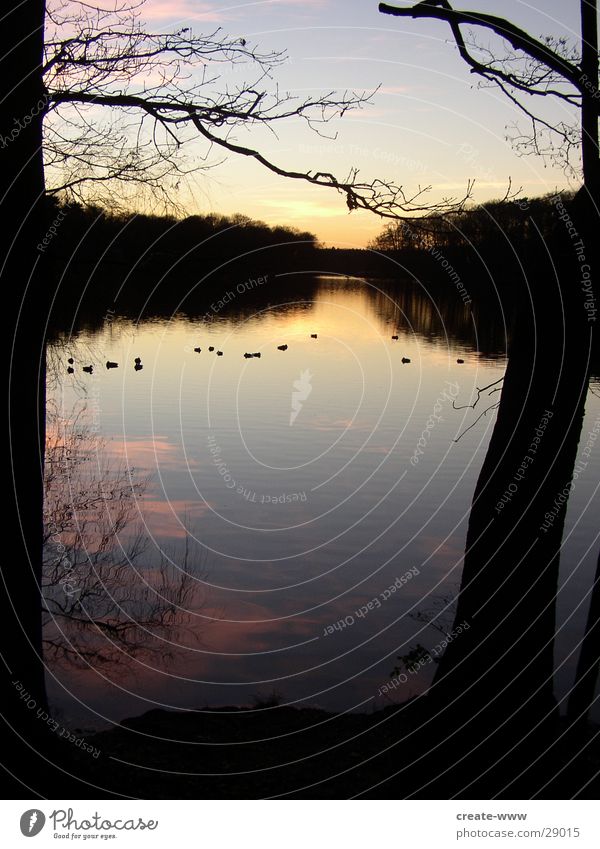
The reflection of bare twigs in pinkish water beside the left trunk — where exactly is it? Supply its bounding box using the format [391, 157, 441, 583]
[42, 404, 204, 675]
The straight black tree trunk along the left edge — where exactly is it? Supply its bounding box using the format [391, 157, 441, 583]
[0, 0, 48, 780]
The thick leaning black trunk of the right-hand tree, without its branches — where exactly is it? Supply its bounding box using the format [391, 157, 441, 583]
[428, 205, 595, 792]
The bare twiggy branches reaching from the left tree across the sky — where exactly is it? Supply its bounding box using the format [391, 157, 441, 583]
[44, 0, 472, 218]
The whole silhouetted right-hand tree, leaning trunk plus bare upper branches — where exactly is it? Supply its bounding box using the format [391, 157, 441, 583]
[380, 0, 600, 795]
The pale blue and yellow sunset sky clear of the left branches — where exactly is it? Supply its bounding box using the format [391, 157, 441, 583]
[143, 0, 579, 247]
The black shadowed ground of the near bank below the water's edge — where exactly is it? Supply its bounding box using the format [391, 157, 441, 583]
[9, 700, 600, 799]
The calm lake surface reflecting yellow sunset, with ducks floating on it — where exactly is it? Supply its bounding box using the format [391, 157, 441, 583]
[49, 278, 600, 725]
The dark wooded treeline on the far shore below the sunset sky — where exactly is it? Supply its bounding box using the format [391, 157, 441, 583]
[40, 191, 575, 268]
